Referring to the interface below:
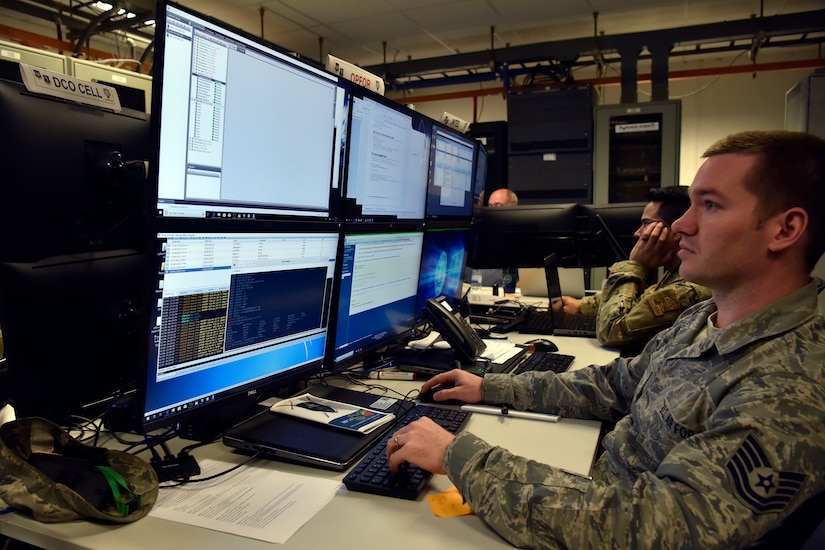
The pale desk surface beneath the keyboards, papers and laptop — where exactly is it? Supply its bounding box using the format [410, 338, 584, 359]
[0, 335, 616, 550]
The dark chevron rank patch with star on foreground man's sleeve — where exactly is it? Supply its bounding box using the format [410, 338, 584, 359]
[727, 435, 806, 514]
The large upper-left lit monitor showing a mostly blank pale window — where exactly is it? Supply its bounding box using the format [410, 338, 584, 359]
[152, 3, 347, 220]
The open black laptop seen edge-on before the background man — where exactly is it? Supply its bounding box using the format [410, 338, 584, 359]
[518, 253, 596, 338]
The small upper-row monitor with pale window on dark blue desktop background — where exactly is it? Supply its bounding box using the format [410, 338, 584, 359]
[427, 122, 476, 220]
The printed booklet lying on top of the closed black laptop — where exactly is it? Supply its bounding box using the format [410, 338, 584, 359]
[269, 393, 395, 433]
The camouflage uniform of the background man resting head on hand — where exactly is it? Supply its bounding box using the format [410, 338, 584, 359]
[581, 260, 710, 349]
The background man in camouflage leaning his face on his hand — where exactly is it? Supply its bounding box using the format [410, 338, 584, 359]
[562, 186, 710, 354]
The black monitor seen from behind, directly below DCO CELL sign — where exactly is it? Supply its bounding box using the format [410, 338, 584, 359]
[0, 66, 151, 263]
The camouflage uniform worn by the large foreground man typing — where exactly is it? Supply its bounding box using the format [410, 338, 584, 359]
[444, 283, 825, 549]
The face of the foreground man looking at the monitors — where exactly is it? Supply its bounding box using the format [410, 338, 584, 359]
[672, 154, 768, 292]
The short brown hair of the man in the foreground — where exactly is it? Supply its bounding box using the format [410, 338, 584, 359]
[702, 130, 825, 271]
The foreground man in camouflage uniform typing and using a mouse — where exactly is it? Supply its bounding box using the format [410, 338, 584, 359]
[387, 132, 825, 549]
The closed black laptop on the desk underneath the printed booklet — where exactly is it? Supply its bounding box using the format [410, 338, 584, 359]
[223, 385, 415, 471]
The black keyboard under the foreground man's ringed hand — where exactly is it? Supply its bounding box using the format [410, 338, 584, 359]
[344, 405, 472, 500]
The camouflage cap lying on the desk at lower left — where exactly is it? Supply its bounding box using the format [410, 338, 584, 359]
[0, 418, 158, 523]
